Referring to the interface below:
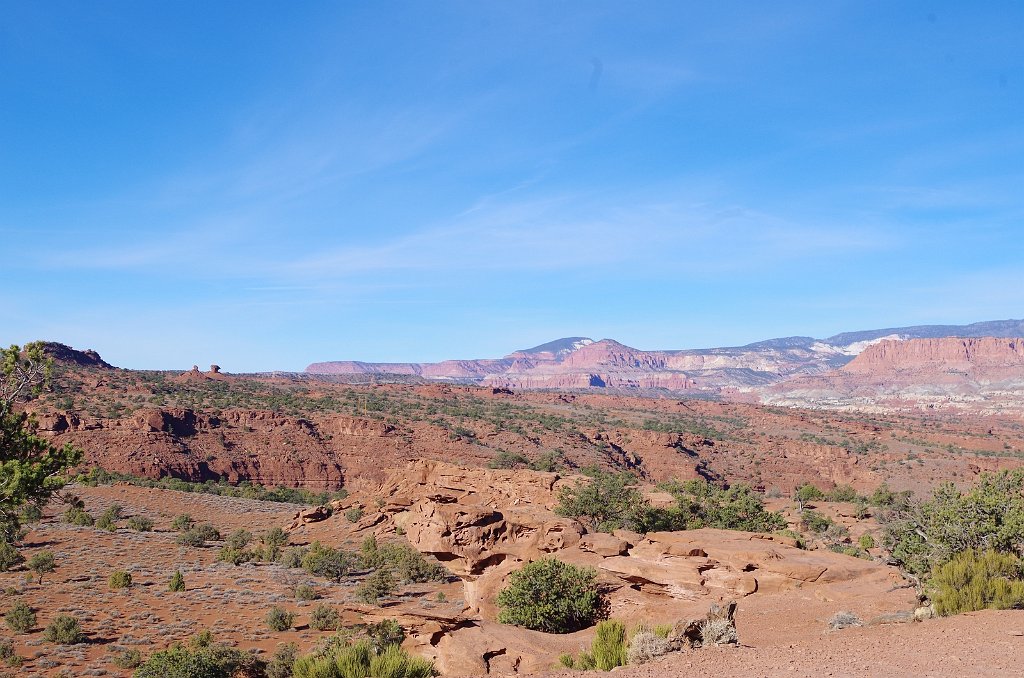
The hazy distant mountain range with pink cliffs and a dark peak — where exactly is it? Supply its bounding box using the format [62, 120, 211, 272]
[306, 320, 1024, 392]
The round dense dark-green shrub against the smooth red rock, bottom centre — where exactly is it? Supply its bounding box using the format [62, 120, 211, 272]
[498, 558, 603, 633]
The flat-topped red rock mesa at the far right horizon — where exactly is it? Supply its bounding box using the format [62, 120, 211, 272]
[843, 337, 1024, 374]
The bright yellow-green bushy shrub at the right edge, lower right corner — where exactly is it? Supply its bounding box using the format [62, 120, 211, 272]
[929, 550, 1024, 617]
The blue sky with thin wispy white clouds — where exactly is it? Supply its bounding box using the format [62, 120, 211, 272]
[0, 0, 1024, 372]
